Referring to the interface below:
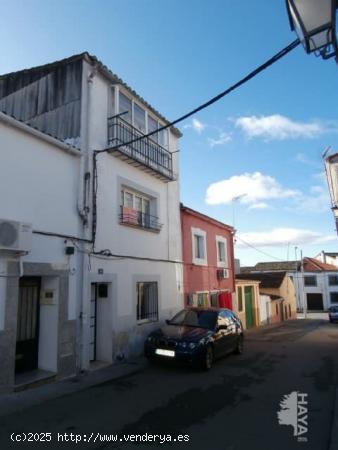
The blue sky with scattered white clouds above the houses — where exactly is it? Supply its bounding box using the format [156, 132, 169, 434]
[0, 0, 338, 265]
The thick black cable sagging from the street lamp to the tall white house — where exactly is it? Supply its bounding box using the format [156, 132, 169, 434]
[97, 39, 300, 153]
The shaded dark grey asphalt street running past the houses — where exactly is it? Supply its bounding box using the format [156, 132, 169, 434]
[0, 319, 338, 450]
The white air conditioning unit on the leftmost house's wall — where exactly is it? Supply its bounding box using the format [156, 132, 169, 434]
[0, 219, 32, 252]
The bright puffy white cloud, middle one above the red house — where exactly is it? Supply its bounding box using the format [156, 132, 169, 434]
[206, 172, 299, 205]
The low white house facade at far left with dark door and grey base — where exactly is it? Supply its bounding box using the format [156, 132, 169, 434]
[0, 113, 81, 391]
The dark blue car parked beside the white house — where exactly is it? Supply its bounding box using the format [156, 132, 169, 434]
[144, 308, 244, 370]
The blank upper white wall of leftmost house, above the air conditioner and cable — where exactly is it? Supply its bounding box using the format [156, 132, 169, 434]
[0, 120, 80, 235]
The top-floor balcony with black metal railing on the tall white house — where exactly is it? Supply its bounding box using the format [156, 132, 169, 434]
[108, 116, 174, 182]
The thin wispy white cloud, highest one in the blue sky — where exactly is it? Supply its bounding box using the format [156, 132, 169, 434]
[234, 114, 326, 140]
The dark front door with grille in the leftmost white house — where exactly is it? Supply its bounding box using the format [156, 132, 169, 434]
[15, 277, 41, 373]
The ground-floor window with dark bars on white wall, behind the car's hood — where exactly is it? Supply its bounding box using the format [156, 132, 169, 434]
[136, 282, 158, 321]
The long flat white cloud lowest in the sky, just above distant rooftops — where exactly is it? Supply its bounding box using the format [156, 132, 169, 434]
[236, 228, 337, 247]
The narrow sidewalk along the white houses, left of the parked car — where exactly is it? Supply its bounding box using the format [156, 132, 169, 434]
[0, 356, 147, 417]
